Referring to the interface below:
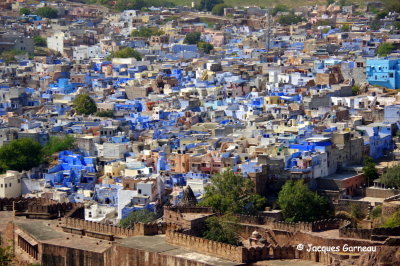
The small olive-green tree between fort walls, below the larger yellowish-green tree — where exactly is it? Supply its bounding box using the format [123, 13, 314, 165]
[203, 214, 239, 245]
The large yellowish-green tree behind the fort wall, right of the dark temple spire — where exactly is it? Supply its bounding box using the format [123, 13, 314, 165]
[199, 170, 266, 214]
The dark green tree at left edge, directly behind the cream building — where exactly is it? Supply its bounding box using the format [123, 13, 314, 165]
[0, 138, 43, 171]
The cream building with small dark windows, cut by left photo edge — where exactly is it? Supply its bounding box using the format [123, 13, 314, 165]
[0, 170, 22, 198]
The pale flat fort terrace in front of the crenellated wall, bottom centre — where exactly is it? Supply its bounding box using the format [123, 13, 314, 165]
[117, 235, 241, 266]
